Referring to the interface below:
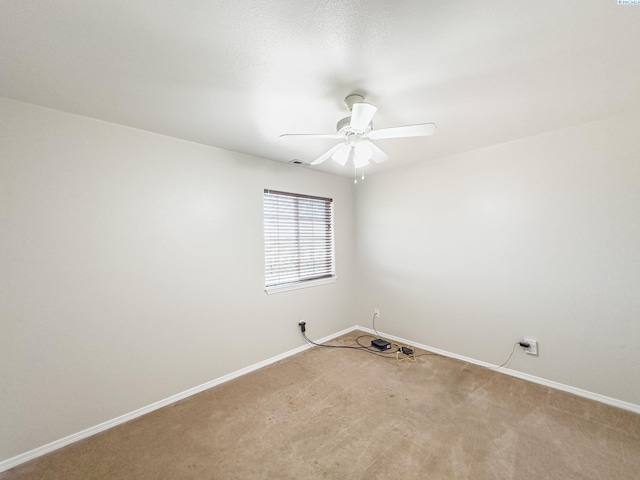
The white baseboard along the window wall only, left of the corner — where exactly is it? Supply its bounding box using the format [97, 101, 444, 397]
[0, 326, 356, 472]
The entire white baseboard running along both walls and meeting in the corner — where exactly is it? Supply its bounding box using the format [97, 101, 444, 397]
[0, 325, 640, 472]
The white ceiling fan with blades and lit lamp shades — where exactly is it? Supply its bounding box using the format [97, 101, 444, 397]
[280, 94, 437, 182]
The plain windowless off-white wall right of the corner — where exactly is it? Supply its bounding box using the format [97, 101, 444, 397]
[356, 112, 640, 405]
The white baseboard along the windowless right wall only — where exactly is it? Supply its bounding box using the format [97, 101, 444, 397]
[355, 325, 640, 413]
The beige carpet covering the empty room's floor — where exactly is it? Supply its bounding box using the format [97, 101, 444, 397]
[0, 333, 640, 480]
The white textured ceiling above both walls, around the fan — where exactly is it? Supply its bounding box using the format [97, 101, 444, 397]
[0, 0, 640, 176]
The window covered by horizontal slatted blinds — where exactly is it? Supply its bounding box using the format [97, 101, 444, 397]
[264, 190, 336, 293]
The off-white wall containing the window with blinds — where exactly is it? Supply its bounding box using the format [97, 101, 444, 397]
[0, 99, 355, 461]
